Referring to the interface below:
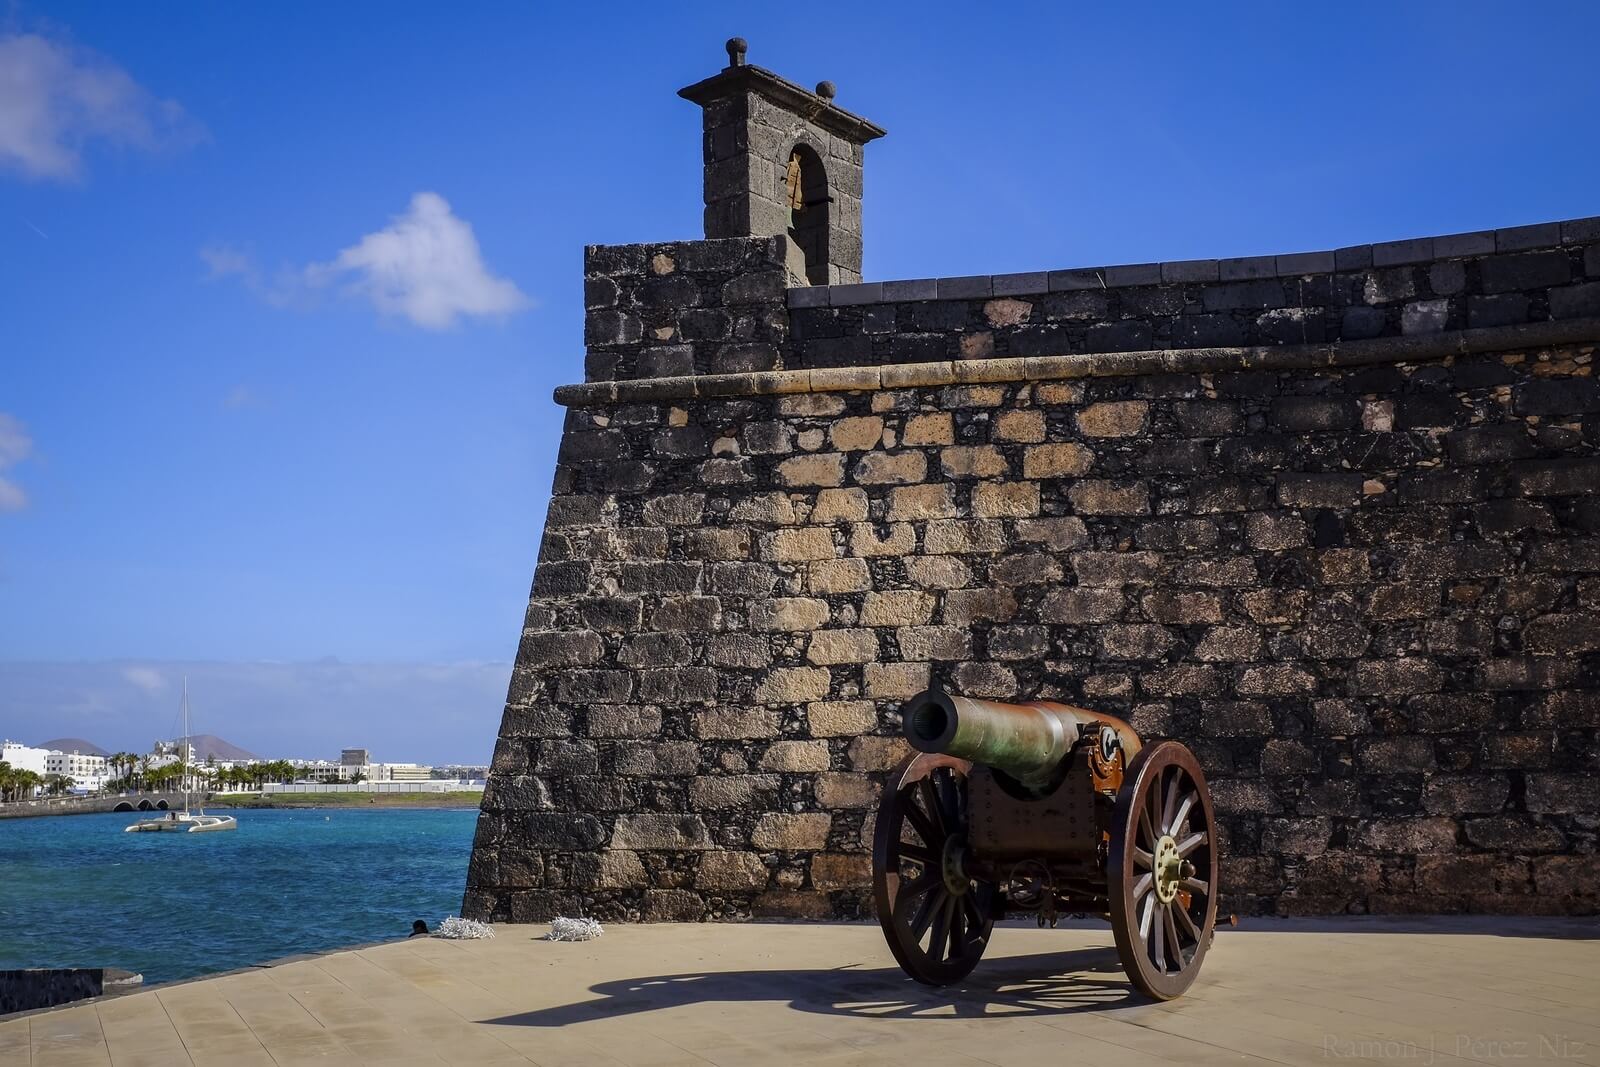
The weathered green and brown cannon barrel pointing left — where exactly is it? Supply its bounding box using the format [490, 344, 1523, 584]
[901, 688, 1141, 787]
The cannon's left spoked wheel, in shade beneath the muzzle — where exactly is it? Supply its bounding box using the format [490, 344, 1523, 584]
[872, 753, 995, 985]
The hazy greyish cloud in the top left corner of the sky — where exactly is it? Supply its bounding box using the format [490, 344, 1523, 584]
[0, 34, 200, 181]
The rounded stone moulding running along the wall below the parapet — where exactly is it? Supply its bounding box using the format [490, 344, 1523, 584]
[555, 318, 1600, 408]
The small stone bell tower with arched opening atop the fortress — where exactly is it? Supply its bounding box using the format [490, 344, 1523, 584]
[678, 37, 883, 285]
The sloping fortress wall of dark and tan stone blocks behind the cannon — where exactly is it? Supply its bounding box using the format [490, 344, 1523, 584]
[462, 45, 1600, 920]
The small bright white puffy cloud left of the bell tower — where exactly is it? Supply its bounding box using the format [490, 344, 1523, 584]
[304, 192, 530, 330]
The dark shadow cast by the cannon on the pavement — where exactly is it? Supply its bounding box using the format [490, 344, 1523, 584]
[485, 947, 1147, 1027]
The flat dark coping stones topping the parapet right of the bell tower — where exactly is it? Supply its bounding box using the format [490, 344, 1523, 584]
[789, 216, 1600, 307]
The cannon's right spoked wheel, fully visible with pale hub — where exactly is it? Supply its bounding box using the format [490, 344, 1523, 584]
[1106, 741, 1218, 1000]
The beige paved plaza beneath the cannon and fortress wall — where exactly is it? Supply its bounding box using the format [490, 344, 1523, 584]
[0, 918, 1600, 1067]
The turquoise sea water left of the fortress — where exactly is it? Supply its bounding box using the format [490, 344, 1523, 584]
[0, 808, 477, 982]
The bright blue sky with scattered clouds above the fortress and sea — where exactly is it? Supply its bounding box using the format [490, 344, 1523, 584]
[0, 2, 1600, 761]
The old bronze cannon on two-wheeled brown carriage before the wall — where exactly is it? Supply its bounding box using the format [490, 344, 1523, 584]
[872, 688, 1218, 1000]
